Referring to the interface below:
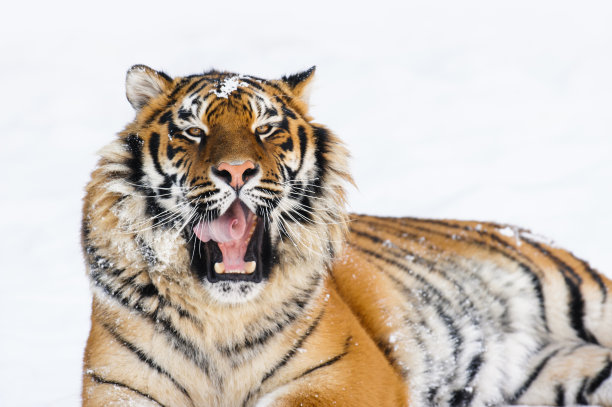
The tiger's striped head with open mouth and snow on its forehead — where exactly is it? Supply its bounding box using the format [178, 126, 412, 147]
[89, 65, 350, 302]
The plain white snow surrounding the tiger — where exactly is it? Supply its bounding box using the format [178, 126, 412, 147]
[0, 0, 612, 406]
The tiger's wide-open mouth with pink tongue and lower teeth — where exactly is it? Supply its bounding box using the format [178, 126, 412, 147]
[189, 199, 264, 283]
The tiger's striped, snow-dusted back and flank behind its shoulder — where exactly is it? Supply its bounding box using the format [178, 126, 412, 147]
[333, 215, 612, 405]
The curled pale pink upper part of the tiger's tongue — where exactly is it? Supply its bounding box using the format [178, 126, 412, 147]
[193, 200, 247, 243]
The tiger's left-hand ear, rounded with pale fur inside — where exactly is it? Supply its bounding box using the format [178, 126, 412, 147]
[125, 65, 172, 111]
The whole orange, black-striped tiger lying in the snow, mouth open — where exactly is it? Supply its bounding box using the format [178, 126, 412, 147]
[81, 65, 612, 407]
